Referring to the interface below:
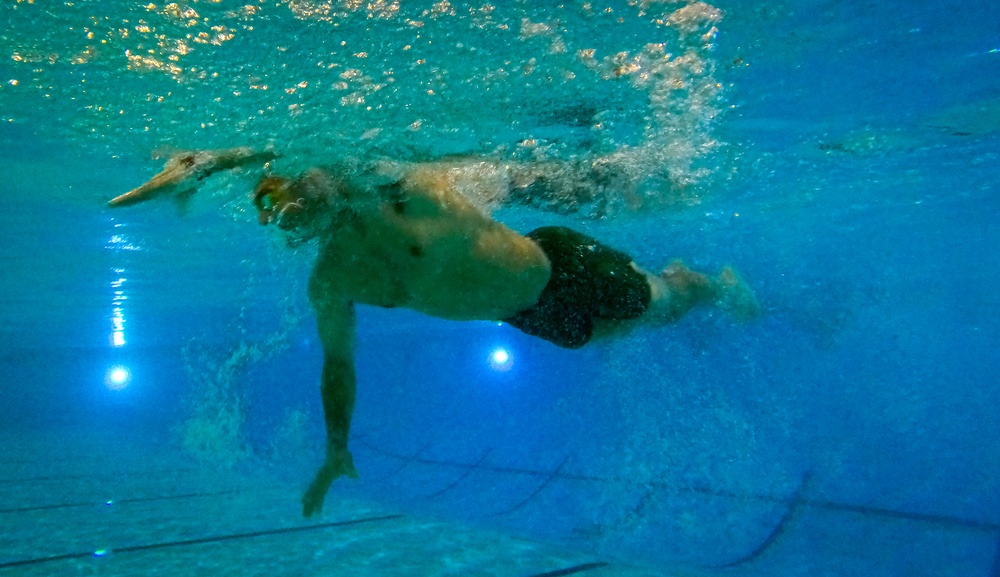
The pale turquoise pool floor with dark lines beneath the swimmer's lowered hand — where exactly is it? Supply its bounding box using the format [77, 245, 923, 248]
[0, 433, 665, 577]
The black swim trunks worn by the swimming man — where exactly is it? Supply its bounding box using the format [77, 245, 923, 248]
[504, 226, 652, 349]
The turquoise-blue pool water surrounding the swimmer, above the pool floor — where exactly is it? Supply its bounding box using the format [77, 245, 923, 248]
[0, 0, 1000, 576]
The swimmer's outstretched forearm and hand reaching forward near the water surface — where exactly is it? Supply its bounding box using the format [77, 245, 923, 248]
[108, 146, 277, 207]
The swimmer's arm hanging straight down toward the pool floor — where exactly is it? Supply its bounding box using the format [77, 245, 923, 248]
[302, 292, 358, 517]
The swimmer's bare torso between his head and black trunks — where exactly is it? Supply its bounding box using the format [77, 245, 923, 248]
[310, 162, 549, 320]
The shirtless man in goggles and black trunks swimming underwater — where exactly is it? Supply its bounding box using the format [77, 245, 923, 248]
[108, 148, 759, 517]
